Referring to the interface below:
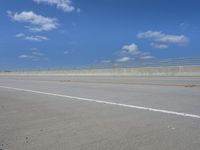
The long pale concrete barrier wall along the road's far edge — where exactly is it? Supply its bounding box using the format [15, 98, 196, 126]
[0, 66, 200, 76]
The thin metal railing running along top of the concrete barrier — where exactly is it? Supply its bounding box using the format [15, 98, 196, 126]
[0, 57, 200, 72]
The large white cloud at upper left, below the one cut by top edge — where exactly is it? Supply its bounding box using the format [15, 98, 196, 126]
[7, 11, 58, 32]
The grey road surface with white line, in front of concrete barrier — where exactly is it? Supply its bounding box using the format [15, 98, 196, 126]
[0, 76, 200, 150]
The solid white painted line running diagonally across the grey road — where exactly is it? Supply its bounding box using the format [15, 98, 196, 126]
[0, 86, 200, 119]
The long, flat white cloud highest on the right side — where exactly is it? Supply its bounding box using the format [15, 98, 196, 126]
[137, 30, 189, 45]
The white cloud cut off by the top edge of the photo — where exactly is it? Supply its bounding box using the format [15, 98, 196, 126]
[33, 0, 75, 12]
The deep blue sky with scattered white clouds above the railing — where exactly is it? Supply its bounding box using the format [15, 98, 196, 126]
[0, 0, 200, 70]
